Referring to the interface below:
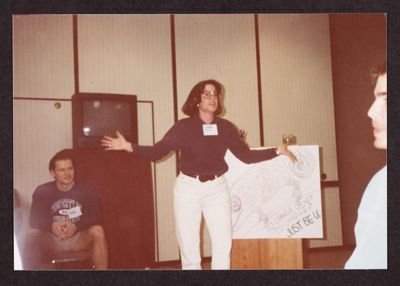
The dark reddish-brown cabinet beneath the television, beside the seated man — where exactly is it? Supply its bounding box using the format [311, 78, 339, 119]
[75, 149, 155, 269]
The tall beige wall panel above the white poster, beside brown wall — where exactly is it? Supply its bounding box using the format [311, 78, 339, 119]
[259, 14, 338, 180]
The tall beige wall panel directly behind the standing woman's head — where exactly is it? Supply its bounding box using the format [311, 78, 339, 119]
[175, 14, 260, 147]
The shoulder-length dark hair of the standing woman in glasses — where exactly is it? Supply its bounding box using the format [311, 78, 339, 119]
[182, 79, 222, 116]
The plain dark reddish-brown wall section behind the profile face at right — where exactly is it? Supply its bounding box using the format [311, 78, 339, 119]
[329, 13, 390, 245]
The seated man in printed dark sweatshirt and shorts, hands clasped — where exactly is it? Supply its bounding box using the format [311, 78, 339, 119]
[24, 150, 108, 269]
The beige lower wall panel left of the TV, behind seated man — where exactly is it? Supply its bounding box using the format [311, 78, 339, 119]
[13, 100, 72, 247]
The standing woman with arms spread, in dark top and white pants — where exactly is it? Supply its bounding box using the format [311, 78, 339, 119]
[101, 80, 297, 269]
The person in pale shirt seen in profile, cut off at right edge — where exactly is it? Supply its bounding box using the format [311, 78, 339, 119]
[344, 64, 387, 269]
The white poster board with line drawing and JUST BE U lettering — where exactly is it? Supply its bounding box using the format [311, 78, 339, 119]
[225, 145, 323, 239]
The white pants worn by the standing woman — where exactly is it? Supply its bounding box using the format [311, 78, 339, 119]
[174, 173, 232, 269]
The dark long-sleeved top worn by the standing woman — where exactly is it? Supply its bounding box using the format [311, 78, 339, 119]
[132, 115, 277, 175]
